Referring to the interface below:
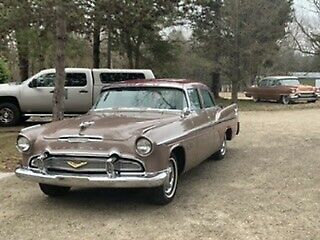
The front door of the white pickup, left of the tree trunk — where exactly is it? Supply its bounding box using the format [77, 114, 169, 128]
[20, 72, 55, 113]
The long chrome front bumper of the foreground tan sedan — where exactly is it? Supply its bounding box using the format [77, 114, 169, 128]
[15, 167, 168, 188]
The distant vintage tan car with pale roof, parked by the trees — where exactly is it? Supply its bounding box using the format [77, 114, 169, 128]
[245, 76, 319, 104]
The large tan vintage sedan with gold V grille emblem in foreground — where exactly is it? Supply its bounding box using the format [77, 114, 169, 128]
[16, 79, 239, 204]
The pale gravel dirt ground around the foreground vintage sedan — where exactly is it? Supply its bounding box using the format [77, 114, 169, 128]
[0, 109, 320, 240]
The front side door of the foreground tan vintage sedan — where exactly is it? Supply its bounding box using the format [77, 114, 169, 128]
[187, 88, 212, 168]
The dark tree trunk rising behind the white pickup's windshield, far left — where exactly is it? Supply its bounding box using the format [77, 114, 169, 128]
[16, 30, 29, 82]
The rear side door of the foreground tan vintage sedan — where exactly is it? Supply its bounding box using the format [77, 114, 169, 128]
[200, 89, 223, 156]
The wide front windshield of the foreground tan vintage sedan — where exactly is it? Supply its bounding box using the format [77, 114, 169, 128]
[94, 87, 187, 110]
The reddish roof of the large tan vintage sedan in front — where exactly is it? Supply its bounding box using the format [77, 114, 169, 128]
[102, 78, 208, 91]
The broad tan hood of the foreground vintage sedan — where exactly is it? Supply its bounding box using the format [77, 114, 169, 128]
[42, 112, 180, 141]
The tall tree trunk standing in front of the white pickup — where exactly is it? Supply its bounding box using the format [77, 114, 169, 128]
[52, 2, 67, 121]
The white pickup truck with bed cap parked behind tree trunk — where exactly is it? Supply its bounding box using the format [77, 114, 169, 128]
[0, 68, 155, 126]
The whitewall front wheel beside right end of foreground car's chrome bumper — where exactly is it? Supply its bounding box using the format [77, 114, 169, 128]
[151, 156, 178, 205]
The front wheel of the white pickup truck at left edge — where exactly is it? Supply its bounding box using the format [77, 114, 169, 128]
[0, 103, 21, 127]
